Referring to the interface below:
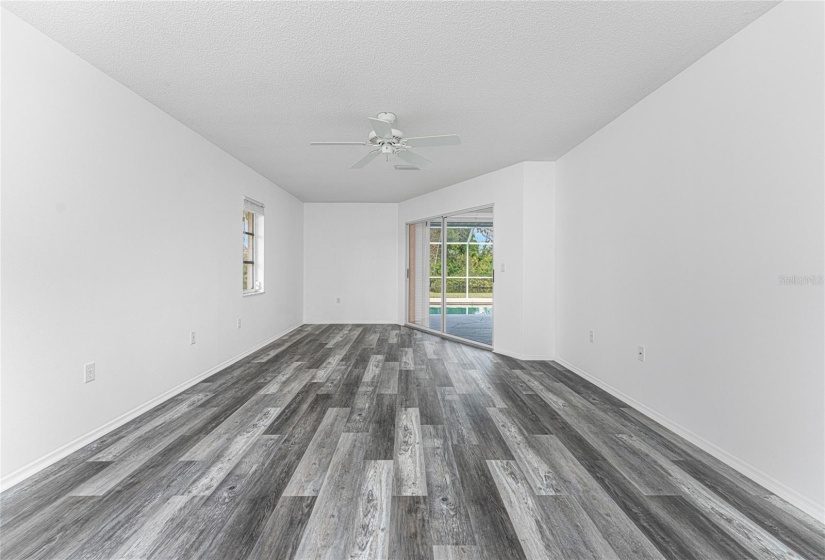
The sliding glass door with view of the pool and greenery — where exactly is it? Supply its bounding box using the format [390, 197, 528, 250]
[407, 207, 493, 346]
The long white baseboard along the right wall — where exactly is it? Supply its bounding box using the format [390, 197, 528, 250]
[555, 357, 825, 521]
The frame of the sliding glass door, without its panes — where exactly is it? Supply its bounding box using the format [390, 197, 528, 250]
[404, 203, 496, 350]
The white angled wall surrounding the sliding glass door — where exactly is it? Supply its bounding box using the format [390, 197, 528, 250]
[396, 162, 555, 359]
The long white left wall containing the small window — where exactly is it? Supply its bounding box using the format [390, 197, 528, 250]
[2, 10, 303, 485]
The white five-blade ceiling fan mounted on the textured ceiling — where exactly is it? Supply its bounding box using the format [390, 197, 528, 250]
[310, 113, 461, 169]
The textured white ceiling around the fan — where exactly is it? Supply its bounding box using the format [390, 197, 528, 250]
[3, 1, 774, 202]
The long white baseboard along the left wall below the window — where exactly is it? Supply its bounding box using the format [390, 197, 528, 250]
[0, 323, 303, 491]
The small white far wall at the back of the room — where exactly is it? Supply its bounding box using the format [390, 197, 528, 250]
[304, 203, 398, 323]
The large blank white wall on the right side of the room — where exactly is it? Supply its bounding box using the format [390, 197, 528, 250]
[556, 2, 825, 515]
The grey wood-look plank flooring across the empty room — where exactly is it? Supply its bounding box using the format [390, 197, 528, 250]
[0, 325, 825, 560]
